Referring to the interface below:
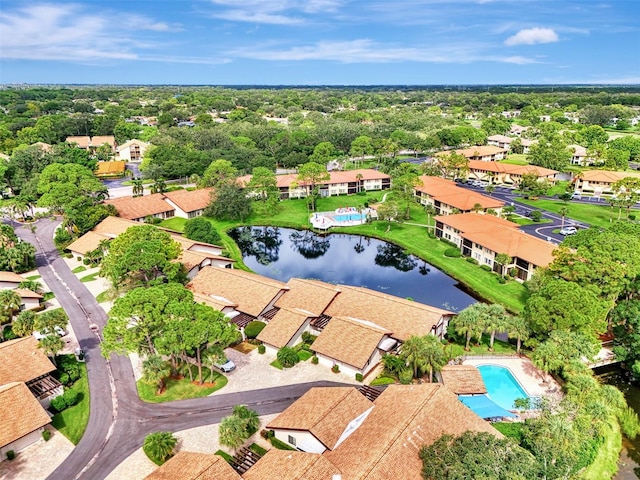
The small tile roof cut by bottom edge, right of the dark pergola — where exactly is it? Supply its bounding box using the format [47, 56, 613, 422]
[242, 448, 340, 480]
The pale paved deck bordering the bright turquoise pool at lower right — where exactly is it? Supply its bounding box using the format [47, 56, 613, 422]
[463, 357, 560, 398]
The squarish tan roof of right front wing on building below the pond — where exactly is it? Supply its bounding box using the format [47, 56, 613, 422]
[311, 317, 391, 369]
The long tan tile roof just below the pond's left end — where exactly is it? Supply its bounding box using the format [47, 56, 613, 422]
[187, 267, 286, 316]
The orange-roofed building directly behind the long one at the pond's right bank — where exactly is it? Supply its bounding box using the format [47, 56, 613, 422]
[414, 175, 504, 215]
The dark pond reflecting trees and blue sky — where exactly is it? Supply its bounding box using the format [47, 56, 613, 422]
[229, 227, 477, 311]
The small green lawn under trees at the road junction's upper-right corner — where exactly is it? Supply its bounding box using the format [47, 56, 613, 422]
[136, 367, 228, 403]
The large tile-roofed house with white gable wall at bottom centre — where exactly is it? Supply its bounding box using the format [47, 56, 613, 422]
[262, 384, 502, 480]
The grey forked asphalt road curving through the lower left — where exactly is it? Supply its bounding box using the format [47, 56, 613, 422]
[16, 219, 348, 480]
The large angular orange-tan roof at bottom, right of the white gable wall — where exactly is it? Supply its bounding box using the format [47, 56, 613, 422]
[324, 384, 502, 480]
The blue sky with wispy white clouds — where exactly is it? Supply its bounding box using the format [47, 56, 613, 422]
[0, 0, 640, 85]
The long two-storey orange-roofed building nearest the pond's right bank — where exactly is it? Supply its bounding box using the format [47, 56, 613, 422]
[434, 213, 556, 281]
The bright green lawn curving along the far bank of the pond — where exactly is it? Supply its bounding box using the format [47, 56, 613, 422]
[198, 191, 526, 313]
